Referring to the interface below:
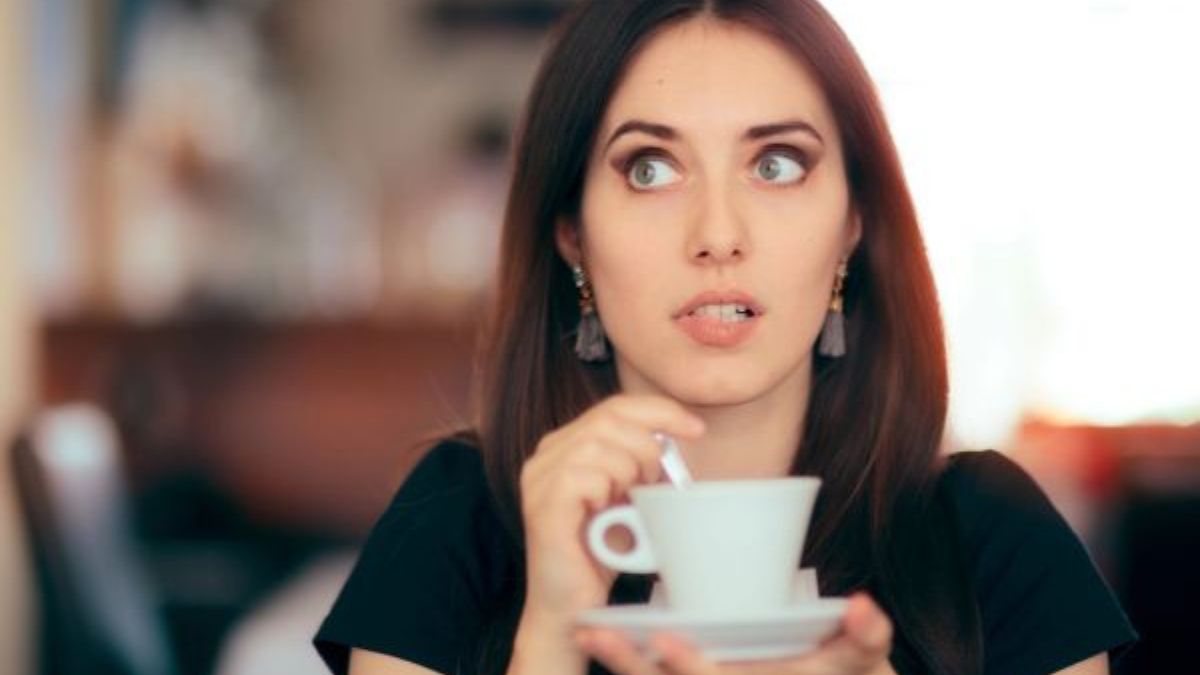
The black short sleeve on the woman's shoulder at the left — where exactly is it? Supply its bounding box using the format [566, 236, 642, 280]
[313, 441, 508, 674]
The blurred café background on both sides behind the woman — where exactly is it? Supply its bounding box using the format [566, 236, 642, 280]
[0, 0, 1200, 675]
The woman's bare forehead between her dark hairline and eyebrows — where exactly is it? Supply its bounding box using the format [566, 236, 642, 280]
[601, 18, 838, 142]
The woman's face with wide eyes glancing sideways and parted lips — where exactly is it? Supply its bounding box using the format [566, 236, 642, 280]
[558, 19, 860, 406]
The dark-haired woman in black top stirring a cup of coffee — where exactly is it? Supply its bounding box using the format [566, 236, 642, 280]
[317, 0, 1133, 675]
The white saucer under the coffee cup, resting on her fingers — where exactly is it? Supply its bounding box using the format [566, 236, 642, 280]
[576, 598, 848, 661]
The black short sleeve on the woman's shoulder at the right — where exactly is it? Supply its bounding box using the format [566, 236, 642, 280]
[947, 450, 1138, 675]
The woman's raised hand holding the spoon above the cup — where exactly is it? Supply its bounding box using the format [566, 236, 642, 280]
[521, 394, 704, 624]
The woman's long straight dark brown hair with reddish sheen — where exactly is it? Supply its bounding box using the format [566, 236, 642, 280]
[476, 0, 983, 675]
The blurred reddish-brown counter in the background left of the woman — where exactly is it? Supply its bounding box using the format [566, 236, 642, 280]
[41, 319, 475, 538]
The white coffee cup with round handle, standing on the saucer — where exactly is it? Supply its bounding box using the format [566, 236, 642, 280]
[587, 477, 821, 616]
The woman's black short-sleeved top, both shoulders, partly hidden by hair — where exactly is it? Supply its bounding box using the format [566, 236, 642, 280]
[314, 441, 1136, 675]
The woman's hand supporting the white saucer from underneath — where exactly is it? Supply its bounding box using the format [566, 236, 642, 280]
[576, 593, 895, 675]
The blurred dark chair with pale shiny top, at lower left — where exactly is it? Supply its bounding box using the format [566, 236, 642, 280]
[12, 405, 178, 675]
